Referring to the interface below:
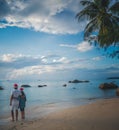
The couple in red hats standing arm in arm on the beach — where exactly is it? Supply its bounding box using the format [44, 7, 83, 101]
[10, 84, 26, 121]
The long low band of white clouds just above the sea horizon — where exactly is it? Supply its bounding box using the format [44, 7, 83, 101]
[0, 54, 92, 79]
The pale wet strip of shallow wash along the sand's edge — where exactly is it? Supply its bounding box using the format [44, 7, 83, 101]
[0, 97, 115, 125]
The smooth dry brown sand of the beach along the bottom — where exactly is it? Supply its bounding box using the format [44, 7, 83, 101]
[0, 98, 119, 130]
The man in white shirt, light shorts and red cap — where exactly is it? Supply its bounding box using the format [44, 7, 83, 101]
[10, 84, 21, 121]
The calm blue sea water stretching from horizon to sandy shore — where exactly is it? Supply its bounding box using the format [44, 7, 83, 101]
[0, 79, 119, 122]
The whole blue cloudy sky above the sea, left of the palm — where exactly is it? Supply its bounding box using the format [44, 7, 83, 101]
[0, 0, 119, 80]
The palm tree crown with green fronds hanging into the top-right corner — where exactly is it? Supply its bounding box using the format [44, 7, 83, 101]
[76, 0, 119, 48]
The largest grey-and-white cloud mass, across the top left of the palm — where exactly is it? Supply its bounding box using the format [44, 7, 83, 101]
[0, 0, 85, 34]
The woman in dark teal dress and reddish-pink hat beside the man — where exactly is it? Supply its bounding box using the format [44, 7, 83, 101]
[19, 88, 26, 119]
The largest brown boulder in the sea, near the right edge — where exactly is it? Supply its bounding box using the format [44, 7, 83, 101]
[99, 82, 118, 89]
